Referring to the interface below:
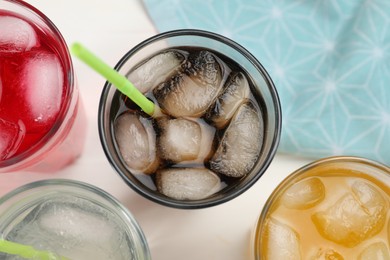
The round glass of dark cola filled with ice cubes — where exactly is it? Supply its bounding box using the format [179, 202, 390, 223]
[99, 30, 281, 209]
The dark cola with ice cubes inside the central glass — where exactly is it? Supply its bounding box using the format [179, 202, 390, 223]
[111, 46, 264, 200]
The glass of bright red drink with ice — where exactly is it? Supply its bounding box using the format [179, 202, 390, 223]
[0, 0, 85, 173]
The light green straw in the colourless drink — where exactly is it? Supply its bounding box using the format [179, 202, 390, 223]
[0, 239, 69, 260]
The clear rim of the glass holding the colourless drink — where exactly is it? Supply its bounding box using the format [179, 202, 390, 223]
[0, 179, 151, 259]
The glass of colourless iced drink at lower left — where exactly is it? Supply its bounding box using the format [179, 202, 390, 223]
[0, 179, 151, 260]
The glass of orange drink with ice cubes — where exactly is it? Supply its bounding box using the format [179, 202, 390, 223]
[253, 157, 390, 260]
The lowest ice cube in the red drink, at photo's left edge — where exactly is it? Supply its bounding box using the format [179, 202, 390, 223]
[0, 118, 26, 160]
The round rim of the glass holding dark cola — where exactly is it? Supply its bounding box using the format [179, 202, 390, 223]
[98, 29, 282, 209]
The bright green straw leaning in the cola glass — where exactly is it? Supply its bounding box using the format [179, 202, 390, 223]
[70, 43, 155, 116]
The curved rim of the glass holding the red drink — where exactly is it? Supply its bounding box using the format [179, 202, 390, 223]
[0, 0, 75, 169]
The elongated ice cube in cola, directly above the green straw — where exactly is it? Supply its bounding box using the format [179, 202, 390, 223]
[128, 51, 185, 93]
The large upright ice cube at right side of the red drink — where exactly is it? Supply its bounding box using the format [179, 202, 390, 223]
[23, 53, 64, 127]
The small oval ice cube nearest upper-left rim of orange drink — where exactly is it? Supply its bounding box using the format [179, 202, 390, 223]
[281, 177, 325, 209]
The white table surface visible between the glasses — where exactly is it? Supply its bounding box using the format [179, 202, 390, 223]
[0, 0, 311, 260]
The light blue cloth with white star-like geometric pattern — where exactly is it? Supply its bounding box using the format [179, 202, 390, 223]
[144, 0, 390, 165]
